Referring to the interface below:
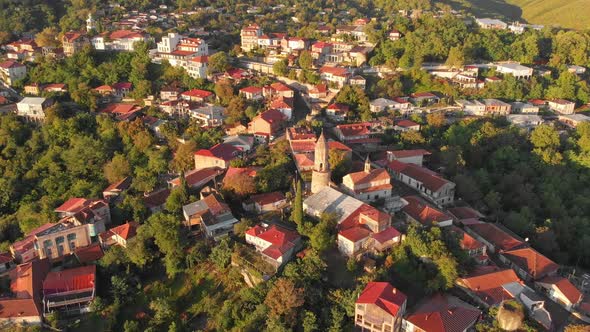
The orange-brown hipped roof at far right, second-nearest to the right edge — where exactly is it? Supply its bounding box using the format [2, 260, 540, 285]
[503, 248, 559, 280]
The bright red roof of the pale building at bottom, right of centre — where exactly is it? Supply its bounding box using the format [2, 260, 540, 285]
[356, 282, 408, 317]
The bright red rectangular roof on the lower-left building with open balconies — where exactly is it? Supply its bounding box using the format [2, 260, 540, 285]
[43, 265, 96, 295]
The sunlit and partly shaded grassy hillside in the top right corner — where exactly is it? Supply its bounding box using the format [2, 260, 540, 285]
[460, 0, 590, 30]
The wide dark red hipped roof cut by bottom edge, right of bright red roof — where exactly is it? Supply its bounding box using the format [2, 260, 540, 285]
[406, 294, 481, 332]
